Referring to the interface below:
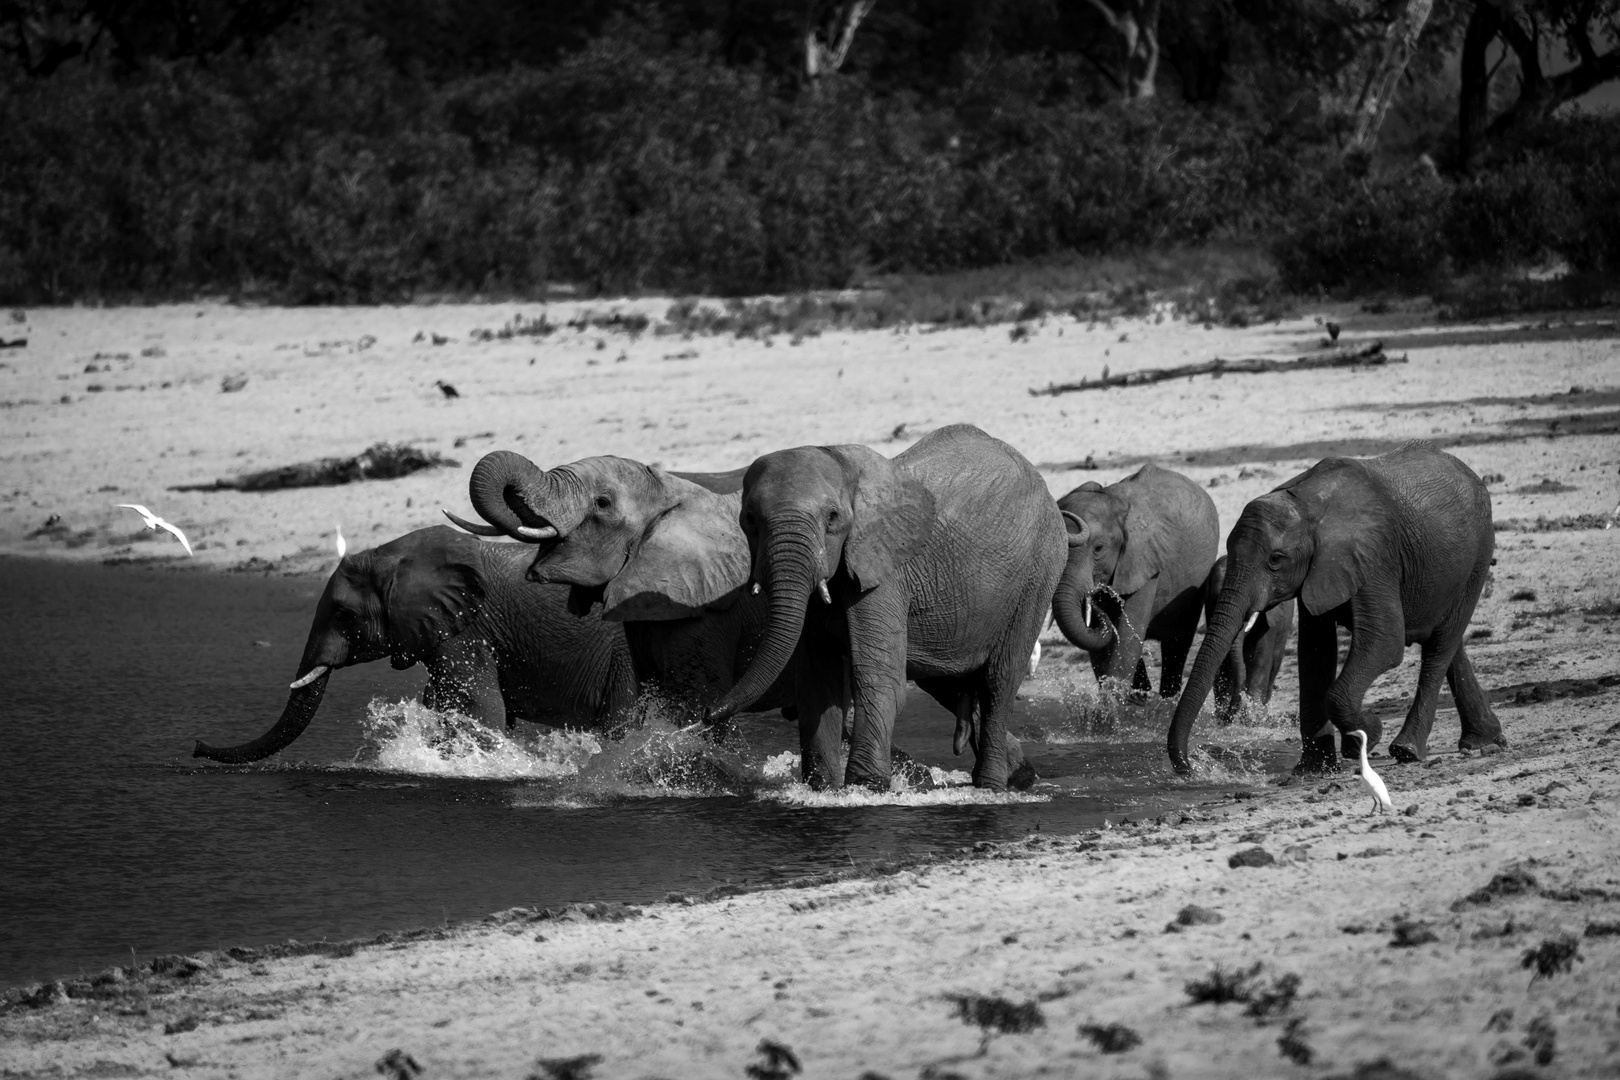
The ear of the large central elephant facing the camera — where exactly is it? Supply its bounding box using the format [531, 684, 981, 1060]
[829, 445, 935, 589]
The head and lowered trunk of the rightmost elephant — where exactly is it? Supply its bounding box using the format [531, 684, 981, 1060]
[1168, 458, 1395, 772]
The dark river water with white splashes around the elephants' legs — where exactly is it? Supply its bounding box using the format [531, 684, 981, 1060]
[0, 559, 1291, 986]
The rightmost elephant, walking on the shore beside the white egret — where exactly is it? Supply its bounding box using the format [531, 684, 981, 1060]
[1168, 442, 1505, 772]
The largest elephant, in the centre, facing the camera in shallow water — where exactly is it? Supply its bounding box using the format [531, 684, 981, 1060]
[710, 424, 1066, 790]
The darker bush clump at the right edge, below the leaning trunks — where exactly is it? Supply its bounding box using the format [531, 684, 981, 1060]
[1273, 115, 1620, 290]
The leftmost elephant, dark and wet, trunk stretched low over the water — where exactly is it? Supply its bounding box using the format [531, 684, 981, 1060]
[193, 525, 635, 764]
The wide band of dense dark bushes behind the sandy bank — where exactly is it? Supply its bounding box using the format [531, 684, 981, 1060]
[0, 28, 1620, 303]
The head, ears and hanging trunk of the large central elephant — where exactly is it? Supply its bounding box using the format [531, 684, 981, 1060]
[710, 445, 935, 731]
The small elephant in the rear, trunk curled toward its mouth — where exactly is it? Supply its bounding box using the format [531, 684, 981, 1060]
[1051, 465, 1220, 698]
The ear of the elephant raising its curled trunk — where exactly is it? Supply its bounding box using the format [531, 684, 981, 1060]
[603, 474, 748, 622]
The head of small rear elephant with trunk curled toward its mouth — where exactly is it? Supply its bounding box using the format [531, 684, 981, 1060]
[1051, 481, 1170, 653]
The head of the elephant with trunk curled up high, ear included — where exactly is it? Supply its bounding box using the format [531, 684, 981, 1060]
[447, 450, 748, 622]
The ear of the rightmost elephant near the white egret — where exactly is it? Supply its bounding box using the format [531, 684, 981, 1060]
[1290, 460, 1396, 615]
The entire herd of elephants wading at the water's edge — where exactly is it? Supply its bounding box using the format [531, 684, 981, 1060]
[196, 424, 1503, 790]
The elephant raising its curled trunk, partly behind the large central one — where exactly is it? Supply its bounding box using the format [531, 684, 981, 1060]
[449, 450, 794, 719]
